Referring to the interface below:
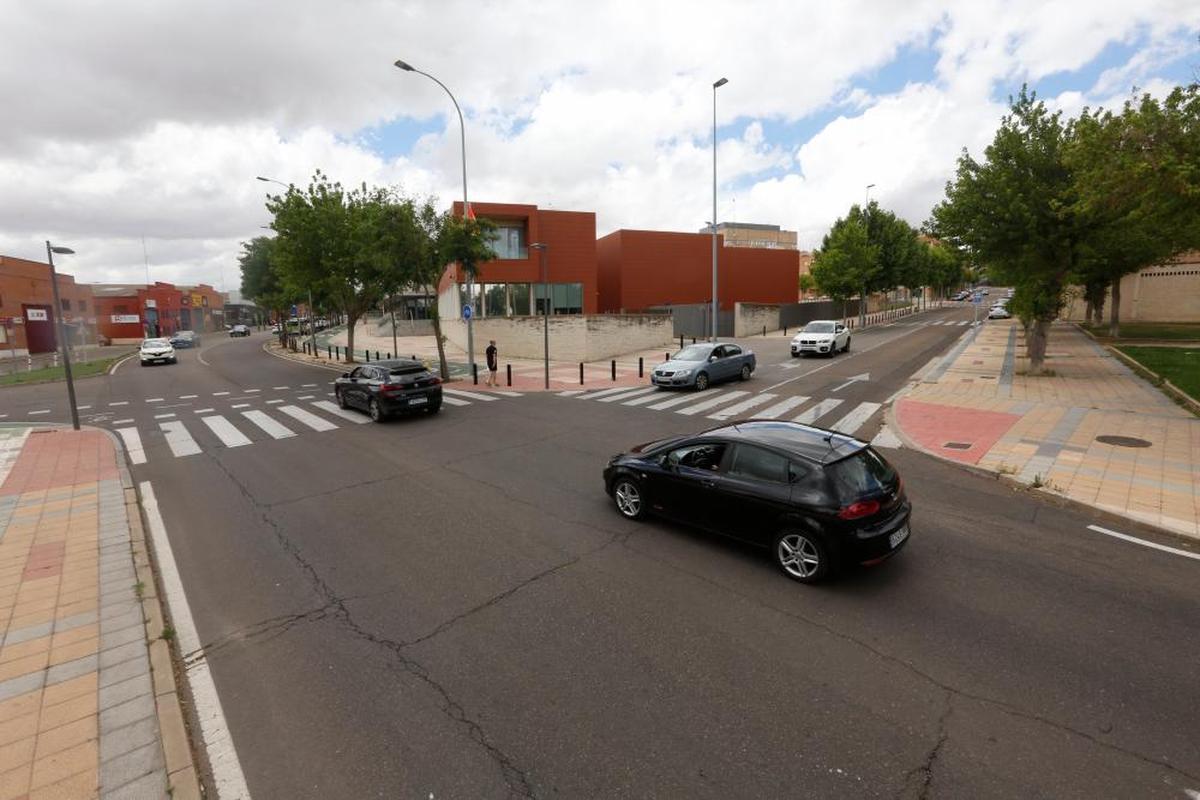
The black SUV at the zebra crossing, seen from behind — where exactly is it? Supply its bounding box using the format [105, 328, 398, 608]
[334, 359, 442, 422]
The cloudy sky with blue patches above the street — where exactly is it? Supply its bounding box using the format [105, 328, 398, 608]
[0, 0, 1200, 288]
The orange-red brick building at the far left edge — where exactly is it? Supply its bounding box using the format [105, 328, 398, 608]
[0, 255, 96, 359]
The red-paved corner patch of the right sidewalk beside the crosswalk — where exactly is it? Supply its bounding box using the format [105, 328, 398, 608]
[896, 399, 1021, 464]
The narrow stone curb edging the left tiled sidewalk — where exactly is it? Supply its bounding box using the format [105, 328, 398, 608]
[97, 426, 204, 800]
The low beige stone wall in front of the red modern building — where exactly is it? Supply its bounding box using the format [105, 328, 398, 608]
[442, 314, 672, 361]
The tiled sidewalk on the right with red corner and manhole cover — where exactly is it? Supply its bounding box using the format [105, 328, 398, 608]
[892, 320, 1200, 537]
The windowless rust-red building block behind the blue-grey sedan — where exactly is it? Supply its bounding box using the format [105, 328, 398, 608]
[596, 230, 800, 312]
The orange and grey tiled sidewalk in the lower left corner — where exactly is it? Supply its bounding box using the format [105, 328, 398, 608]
[0, 426, 200, 800]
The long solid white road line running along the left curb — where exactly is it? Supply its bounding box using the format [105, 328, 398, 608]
[138, 481, 250, 800]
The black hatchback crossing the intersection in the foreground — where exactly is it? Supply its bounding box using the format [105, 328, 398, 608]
[604, 420, 912, 583]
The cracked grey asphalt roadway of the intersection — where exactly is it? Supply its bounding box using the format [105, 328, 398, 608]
[0, 311, 1200, 799]
